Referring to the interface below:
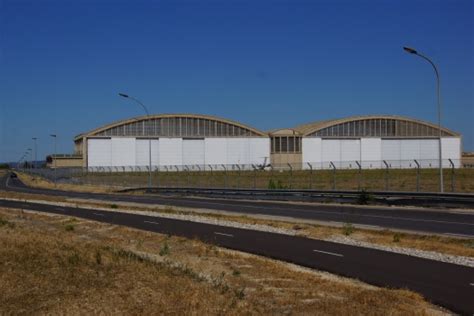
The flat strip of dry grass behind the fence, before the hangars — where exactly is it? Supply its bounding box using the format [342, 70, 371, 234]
[70, 168, 474, 192]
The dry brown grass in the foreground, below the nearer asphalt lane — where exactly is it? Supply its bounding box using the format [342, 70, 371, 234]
[0, 210, 441, 315]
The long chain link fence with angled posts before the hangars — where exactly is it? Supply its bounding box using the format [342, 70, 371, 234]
[18, 159, 474, 192]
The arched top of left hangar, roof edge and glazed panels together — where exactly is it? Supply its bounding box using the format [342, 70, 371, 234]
[74, 114, 267, 141]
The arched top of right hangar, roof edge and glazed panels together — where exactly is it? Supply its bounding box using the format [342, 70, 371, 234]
[295, 115, 459, 137]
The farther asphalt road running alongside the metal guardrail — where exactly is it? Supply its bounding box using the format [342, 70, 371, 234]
[0, 177, 474, 238]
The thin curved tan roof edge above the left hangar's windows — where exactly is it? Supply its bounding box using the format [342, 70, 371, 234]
[74, 114, 268, 141]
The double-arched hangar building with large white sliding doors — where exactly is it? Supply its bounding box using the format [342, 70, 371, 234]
[74, 114, 462, 171]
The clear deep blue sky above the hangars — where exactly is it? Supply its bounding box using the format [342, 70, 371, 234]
[0, 0, 474, 161]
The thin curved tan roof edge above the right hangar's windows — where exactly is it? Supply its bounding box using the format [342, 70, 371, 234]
[294, 115, 460, 136]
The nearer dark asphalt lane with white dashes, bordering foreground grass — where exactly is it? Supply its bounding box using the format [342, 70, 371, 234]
[0, 200, 474, 315]
